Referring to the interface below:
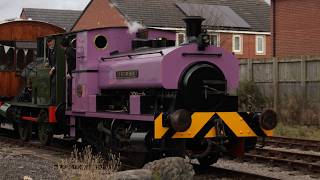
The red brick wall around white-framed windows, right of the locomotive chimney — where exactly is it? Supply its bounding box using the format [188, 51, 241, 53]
[220, 33, 272, 59]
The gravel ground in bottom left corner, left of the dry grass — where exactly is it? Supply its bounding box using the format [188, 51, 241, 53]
[0, 148, 61, 180]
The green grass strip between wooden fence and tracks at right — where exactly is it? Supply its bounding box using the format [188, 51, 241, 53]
[274, 122, 320, 141]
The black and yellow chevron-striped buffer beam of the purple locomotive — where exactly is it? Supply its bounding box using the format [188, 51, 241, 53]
[154, 112, 272, 139]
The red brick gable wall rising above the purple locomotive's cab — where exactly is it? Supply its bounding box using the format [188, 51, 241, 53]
[71, 0, 126, 31]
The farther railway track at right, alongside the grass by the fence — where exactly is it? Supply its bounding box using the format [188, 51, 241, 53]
[260, 136, 320, 152]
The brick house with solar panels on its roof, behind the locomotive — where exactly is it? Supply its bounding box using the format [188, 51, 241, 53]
[72, 0, 272, 58]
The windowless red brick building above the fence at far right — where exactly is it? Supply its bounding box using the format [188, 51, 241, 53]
[271, 0, 320, 57]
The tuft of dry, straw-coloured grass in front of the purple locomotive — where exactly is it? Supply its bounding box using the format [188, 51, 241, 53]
[58, 146, 121, 180]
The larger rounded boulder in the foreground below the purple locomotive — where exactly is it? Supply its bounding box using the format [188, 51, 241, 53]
[143, 157, 195, 180]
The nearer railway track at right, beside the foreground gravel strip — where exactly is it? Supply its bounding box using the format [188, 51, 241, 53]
[243, 148, 320, 175]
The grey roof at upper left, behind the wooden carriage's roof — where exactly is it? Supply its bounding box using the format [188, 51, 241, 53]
[21, 8, 82, 31]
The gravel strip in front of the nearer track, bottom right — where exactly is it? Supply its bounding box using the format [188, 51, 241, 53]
[214, 159, 320, 180]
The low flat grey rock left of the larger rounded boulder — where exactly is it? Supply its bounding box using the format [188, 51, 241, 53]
[106, 169, 153, 180]
